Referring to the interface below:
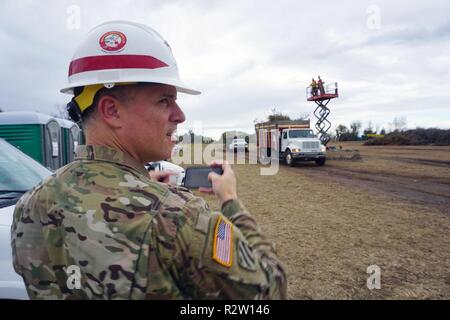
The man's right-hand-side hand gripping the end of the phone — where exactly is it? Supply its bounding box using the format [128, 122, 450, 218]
[198, 161, 237, 205]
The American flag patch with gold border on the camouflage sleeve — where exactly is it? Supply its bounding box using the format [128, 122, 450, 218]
[213, 217, 233, 267]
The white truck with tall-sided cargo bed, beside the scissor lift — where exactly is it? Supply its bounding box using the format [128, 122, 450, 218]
[255, 120, 326, 167]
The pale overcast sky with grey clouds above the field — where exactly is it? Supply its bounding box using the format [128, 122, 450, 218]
[0, 0, 450, 138]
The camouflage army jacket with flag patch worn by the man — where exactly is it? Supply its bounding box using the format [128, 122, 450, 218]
[11, 146, 286, 299]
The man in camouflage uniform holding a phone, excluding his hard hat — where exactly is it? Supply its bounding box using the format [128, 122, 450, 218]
[11, 20, 286, 299]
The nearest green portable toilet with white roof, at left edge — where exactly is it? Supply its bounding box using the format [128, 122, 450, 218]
[0, 112, 63, 170]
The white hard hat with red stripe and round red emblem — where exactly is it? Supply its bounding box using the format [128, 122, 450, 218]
[61, 21, 200, 94]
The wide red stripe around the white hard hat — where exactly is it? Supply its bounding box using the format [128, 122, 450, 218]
[69, 54, 168, 77]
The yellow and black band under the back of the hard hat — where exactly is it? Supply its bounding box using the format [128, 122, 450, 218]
[66, 82, 136, 123]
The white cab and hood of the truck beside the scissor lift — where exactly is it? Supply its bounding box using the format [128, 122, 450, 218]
[280, 128, 326, 166]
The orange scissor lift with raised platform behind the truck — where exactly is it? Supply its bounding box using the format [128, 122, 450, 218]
[306, 82, 339, 146]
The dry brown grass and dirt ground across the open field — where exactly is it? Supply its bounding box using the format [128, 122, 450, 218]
[191, 143, 450, 299]
